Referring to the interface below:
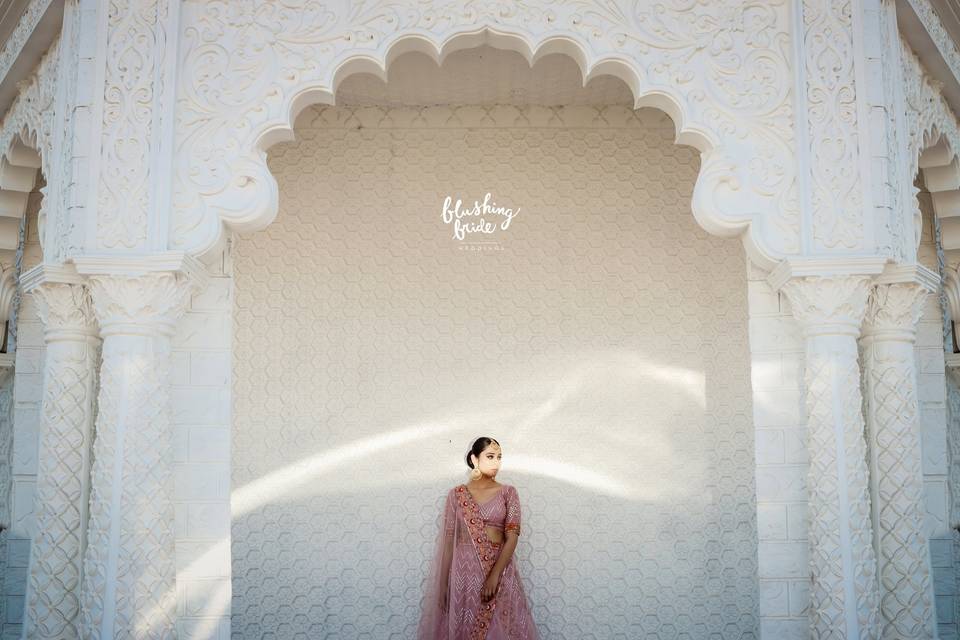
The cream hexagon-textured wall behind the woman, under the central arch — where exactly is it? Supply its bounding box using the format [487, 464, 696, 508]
[231, 106, 759, 639]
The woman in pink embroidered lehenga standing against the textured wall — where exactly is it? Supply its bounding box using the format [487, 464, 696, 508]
[417, 437, 540, 640]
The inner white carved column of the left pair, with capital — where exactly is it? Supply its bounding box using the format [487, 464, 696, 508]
[77, 256, 202, 640]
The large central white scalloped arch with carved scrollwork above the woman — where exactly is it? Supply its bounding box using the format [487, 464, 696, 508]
[170, 0, 800, 265]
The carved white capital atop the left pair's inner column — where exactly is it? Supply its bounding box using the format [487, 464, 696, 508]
[74, 252, 207, 336]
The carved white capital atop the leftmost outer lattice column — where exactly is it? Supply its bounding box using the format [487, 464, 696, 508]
[20, 264, 97, 344]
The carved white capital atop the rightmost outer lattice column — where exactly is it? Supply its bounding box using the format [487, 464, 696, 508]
[863, 264, 940, 342]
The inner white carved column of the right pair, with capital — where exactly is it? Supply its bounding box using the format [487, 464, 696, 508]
[770, 263, 880, 640]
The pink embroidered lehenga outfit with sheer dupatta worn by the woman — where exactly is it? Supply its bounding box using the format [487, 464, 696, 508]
[417, 484, 540, 640]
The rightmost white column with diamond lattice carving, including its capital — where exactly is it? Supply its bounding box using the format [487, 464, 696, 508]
[861, 266, 939, 640]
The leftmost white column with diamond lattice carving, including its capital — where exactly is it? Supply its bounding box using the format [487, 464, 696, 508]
[21, 265, 100, 640]
